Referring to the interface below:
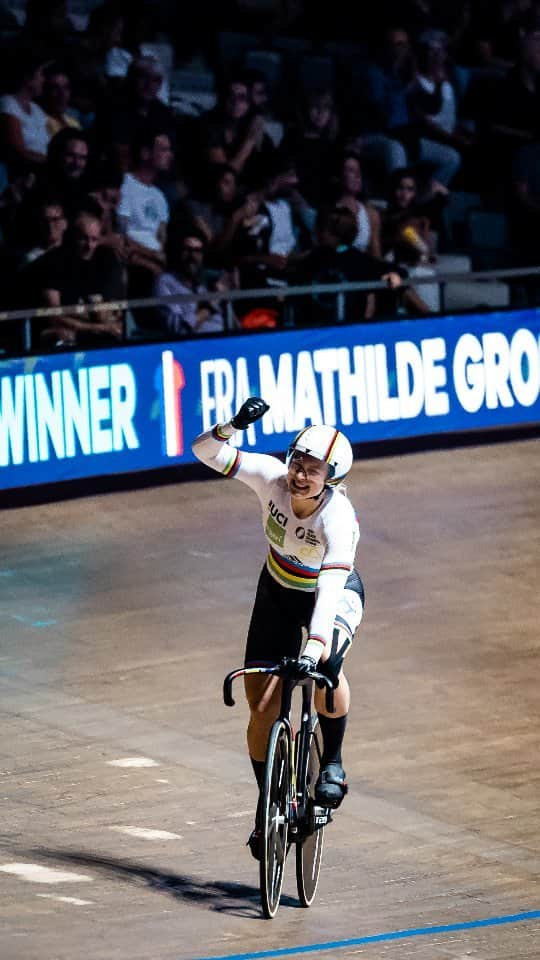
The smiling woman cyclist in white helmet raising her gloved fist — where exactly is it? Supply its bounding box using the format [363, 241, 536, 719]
[193, 397, 364, 859]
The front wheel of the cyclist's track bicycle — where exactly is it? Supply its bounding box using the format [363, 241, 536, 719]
[260, 720, 291, 919]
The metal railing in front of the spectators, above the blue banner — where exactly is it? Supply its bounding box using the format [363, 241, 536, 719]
[0, 264, 540, 353]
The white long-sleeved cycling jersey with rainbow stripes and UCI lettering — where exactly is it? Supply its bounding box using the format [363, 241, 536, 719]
[192, 424, 360, 661]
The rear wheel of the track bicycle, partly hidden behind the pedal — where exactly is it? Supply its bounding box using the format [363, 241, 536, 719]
[296, 717, 324, 907]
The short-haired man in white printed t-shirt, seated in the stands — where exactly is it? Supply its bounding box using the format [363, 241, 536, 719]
[118, 127, 173, 273]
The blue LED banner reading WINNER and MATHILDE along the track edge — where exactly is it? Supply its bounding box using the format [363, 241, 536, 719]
[0, 310, 540, 489]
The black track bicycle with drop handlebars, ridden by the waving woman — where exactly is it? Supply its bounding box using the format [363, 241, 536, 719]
[223, 658, 334, 919]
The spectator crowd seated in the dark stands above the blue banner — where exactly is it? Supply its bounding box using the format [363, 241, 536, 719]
[0, 0, 540, 354]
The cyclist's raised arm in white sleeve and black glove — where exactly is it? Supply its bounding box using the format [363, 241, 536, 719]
[192, 397, 285, 490]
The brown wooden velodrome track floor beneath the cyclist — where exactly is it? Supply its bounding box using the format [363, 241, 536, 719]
[0, 439, 540, 960]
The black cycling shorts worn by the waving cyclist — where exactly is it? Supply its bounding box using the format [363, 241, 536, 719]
[244, 566, 364, 666]
